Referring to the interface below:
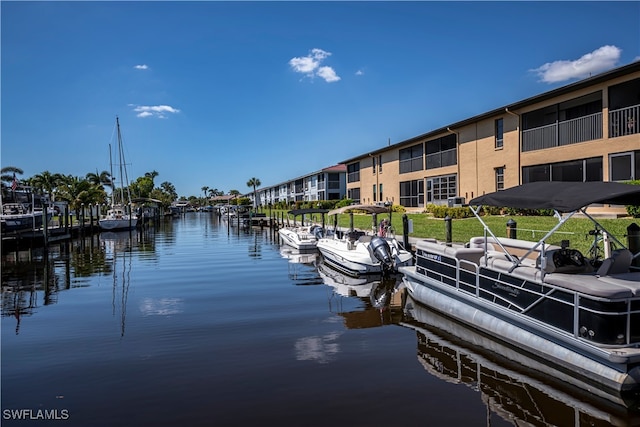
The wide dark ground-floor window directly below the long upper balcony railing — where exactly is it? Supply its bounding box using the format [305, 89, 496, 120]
[522, 157, 602, 184]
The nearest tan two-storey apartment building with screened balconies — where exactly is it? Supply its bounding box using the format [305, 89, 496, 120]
[341, 61, 640, 211]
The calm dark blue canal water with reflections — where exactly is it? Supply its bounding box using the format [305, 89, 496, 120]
[1, 213, 640, 427]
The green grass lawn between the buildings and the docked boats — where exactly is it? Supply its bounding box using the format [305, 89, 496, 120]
[273, 211, 640, 254]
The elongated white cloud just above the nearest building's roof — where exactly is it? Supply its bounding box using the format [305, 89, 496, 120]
[531, 45, 622, 83]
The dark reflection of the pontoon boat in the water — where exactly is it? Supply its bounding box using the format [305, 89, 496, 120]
[401, 296, 640, 426]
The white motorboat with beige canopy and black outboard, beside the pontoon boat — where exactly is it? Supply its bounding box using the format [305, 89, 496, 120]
[316, 205, 413, 277]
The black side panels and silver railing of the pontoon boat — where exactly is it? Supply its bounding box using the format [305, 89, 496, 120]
[416, 246, 640, 348]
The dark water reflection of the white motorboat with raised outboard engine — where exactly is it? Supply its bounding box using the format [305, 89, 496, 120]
[318, 262, 402, 329]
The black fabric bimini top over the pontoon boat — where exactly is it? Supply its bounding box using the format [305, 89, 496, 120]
[469, 181, 640, 212]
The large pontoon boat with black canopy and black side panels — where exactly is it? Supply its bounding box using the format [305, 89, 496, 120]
[399, 182, 640, 394]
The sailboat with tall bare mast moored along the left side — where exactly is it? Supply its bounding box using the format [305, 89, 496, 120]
[99, 117, 138, 231]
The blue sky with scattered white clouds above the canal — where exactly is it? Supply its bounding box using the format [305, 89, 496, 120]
[0, 1, 640, 196]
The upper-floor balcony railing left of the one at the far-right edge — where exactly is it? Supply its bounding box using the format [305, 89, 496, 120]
[522, 113, 602, 151]
